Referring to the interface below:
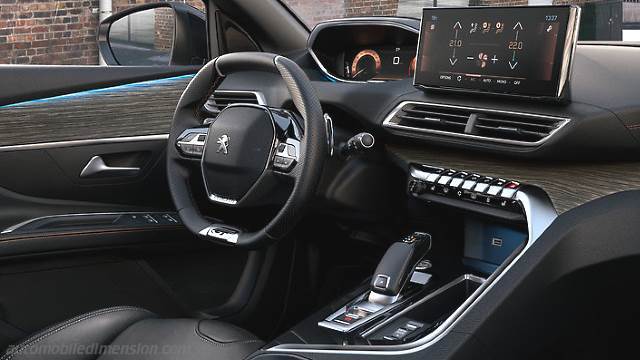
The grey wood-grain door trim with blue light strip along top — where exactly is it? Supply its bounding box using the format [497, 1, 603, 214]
[0, 75, 193, 150]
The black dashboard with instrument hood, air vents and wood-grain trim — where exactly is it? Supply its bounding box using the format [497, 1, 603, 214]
[214, 12, 640, 219]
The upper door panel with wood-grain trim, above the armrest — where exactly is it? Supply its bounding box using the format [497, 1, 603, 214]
[0, 66, 195, 226]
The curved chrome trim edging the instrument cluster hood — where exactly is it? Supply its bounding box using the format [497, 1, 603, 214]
[307, 17, 420, 84]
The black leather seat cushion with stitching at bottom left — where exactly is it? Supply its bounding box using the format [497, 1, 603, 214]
[0, 306, 264, 360]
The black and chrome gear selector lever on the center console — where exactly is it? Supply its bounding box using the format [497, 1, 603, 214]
[369, 232, 431, 305]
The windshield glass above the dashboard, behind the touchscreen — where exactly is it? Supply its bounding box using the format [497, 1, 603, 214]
[281, 0, 640, 41]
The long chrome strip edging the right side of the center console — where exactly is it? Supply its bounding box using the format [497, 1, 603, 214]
[267, 187, 557, 356]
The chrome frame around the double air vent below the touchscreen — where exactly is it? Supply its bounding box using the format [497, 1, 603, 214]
[382, 101, 571, 146]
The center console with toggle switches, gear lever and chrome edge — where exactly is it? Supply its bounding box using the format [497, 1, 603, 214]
[266, 164, 556, 353]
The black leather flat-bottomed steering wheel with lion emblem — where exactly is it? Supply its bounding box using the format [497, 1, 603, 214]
[167, 53, 328, 248]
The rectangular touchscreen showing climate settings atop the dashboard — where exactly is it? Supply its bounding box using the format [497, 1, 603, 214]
[415, 6, 578, 97]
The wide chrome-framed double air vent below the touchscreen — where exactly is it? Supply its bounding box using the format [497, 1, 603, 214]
[383, 102, 569, 146]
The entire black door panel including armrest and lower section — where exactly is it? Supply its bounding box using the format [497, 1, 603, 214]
[0, 66, 270, 347]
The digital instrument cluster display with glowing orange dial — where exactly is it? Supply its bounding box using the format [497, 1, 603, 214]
[344, 46, 417, 81]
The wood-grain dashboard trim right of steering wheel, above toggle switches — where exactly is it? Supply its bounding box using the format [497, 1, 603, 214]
[387, 144, 640, 214]
